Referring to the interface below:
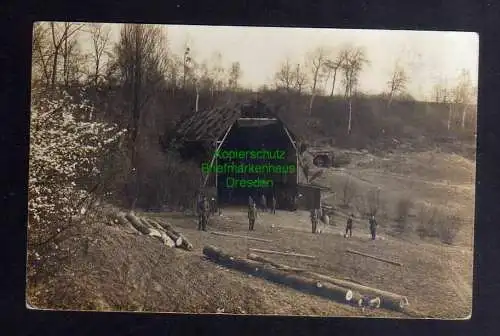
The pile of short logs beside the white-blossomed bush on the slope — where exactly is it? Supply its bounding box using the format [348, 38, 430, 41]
[115, 212, 193, 251]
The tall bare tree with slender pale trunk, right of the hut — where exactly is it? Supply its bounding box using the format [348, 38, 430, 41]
[342, 47, 368, 134]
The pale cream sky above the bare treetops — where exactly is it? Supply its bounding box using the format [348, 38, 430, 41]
[75, 24, 479, 100]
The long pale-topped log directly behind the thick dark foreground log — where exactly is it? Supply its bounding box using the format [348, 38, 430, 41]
[248, 254, 408, 311]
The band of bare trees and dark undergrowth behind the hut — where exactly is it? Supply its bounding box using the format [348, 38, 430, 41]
[32, 23, 476, 214]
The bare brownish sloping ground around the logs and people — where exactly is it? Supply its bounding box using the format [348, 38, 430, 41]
[28, 149, 474, 319]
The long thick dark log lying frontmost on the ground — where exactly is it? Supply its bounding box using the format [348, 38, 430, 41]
[203, 246, 353, 303]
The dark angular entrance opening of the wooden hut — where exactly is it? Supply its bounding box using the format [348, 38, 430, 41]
[217, 118, 297, 208]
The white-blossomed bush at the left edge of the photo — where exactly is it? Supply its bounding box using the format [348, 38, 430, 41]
[28, 92, 125, 248]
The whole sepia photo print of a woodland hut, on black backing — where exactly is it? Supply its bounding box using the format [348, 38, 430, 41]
[26, 22, 480, 320]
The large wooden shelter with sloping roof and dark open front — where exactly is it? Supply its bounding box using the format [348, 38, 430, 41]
[168, 100, 322, 210]
